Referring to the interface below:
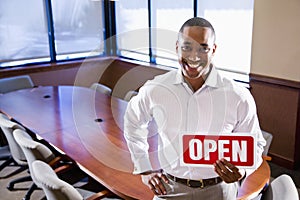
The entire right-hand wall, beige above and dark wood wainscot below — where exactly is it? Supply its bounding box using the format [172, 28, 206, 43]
[250, 0, 300, 168]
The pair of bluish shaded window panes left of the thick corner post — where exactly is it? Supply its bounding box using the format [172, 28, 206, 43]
[0, 0, 104, 67]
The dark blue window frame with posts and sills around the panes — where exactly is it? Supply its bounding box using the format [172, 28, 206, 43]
[0, 0, 249, 84]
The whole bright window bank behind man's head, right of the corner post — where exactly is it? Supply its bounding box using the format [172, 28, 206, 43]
[116, 0, 254, 82]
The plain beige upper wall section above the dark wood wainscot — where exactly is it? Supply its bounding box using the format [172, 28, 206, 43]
[251, 0, 300, 81]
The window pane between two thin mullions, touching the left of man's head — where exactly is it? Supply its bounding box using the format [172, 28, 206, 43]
[151, 0, 193, 67]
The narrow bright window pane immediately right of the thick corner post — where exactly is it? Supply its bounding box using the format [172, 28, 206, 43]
[116, 0, 150, 62]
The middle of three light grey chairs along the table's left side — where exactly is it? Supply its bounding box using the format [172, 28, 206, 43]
[13, 129, 55, 182]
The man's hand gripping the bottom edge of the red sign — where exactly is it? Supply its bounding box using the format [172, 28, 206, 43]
[214, 158, 245, 183]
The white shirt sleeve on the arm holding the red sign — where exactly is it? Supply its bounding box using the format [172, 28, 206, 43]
[234, 91, 266, 176]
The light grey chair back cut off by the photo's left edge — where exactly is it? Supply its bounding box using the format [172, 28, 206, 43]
[0, 113, 27, 165]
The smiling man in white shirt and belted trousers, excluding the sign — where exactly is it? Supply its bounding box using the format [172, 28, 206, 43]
[124, 17, 265, 200]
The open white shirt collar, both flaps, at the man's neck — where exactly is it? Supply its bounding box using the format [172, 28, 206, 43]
[173, 65, 220, 88]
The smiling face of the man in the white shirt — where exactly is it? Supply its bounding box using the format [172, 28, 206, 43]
[176, 26, 216, 79]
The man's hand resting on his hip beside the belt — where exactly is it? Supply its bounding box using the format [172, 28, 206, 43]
[141, 171, 169, 195]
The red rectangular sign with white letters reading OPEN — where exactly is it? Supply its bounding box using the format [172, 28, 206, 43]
[182, 133, 256, 167]
